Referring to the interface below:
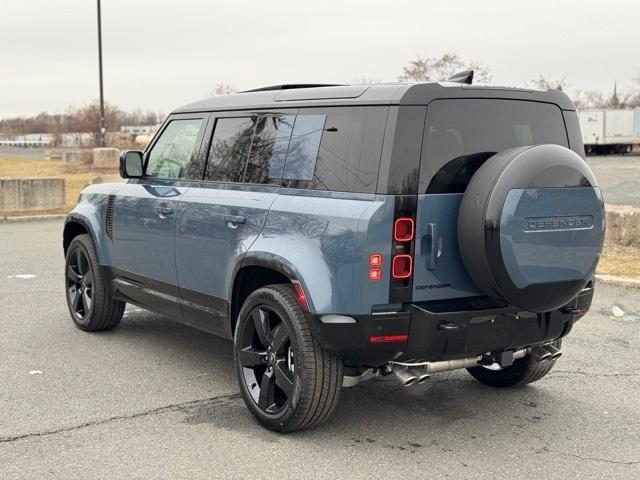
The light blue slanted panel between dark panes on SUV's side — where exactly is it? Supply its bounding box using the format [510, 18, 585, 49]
[282, 115, 327, 180]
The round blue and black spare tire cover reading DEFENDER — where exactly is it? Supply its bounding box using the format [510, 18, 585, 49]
[458, 145, 604, 312]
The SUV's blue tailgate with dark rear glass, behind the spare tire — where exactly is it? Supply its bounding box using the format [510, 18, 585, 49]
[413, 98, 568, 301]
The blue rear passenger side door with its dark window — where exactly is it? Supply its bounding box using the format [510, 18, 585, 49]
[175, 109, 296, 334]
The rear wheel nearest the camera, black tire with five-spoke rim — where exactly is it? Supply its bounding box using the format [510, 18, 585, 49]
[234, 285, 343, 432]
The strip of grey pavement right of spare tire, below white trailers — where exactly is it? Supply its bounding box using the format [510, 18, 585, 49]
[587, 155, 640, 208]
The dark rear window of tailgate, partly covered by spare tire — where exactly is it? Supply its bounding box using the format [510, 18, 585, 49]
[419, 99, 568, 193]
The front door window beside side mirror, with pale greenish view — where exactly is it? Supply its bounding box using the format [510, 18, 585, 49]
[146, 118, 203, 179]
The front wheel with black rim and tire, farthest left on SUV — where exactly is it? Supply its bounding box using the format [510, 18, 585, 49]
[65, 234, 126, 332]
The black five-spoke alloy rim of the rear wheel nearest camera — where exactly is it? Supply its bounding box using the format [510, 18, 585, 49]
[236, 305, 295, 415]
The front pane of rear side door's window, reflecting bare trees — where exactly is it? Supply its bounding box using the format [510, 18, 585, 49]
[205, 117, 256, 182]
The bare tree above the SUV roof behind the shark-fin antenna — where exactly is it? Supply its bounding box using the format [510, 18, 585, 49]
[398, 52, 493, 83]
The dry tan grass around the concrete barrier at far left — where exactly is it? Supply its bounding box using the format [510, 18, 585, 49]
[0, 158, 118, 215]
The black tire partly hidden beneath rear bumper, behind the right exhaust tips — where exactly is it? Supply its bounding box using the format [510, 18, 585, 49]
[467, 340, 562, 388]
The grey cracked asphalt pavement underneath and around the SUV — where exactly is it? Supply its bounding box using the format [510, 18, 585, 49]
[0, 221, 640, 479]
